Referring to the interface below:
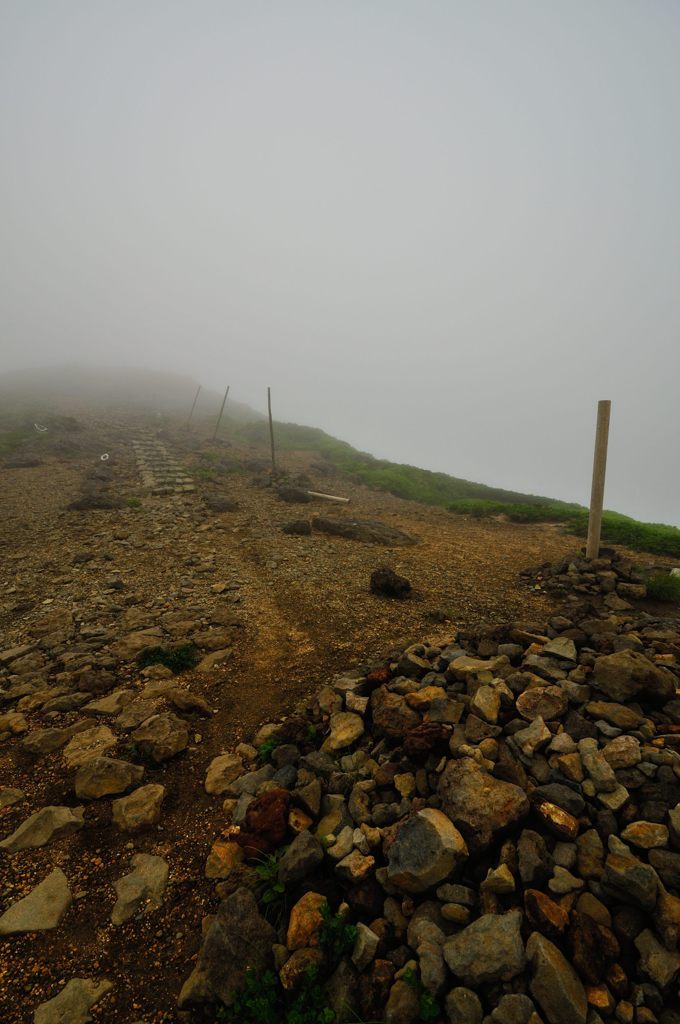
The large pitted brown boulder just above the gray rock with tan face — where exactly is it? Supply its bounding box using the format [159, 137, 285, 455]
[438, 758, 529, 853]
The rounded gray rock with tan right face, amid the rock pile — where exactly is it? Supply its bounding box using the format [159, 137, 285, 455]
[387, 807, 468, 893]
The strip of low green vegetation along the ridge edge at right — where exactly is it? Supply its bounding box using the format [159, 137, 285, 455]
[235, 422, 680, 558]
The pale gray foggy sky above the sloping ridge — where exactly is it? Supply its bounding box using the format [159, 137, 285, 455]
[0, 0, 680, 525]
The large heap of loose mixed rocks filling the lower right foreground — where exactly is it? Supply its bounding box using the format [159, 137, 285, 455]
[187, 598, 680, 1024]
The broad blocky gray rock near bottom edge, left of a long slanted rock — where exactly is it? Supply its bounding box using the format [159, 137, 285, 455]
[443, 910, 526, 987]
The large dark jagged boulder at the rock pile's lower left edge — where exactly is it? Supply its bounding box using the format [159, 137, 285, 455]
[177, 889, 277, 1010]
